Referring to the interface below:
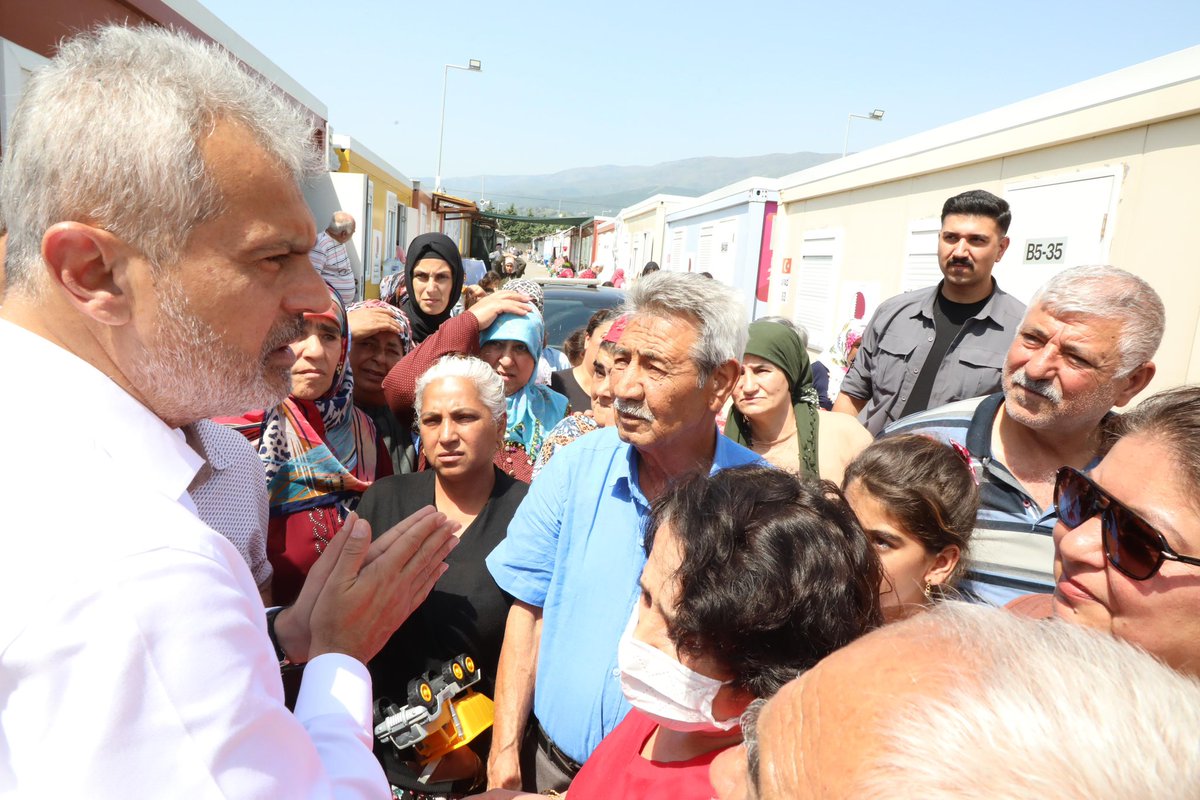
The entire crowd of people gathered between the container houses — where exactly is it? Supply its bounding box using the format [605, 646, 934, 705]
[0, 26, 1200, 800]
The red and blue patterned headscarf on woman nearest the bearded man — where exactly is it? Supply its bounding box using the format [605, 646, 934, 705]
[223, 289, 378, 517]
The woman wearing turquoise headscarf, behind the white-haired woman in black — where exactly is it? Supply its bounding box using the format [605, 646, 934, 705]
[479, 309, 566, 482]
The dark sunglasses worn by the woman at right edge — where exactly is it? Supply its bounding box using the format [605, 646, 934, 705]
[1054, 467, 1200, 581]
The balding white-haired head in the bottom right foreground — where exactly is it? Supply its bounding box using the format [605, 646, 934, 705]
[709, 602, 1200, 800]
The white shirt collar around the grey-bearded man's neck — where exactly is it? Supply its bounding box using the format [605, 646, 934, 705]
[0, 320, 204, 511]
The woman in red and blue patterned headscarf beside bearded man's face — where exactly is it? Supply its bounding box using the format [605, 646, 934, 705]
[225, 284, 392, 604]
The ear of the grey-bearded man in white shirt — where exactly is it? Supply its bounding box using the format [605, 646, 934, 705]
[42, 222, 132, 325]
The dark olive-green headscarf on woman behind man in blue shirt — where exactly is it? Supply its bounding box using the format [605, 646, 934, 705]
[725, 320, 820, 477]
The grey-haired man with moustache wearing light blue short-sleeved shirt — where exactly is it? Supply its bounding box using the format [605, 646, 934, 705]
[487, 272, 760, 792]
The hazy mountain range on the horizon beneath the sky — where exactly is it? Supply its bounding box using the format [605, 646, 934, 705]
[422, 152, 839, 216]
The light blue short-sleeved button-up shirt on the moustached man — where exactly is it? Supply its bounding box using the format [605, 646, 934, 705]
[487, 428, 762, 764]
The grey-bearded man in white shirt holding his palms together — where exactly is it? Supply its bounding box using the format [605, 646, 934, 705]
[0, 28, 454, 798]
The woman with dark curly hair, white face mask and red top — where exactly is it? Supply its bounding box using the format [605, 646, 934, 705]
[463, 467, 882, 800]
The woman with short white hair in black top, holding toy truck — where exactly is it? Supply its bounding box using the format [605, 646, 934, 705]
[359, 356, 528, 794]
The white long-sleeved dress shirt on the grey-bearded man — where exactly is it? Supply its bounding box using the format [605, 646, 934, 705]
[0, 320, 390, 799]
